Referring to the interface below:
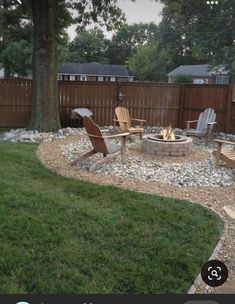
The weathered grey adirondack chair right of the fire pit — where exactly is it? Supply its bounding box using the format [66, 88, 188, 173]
[186, 108, 217, 143]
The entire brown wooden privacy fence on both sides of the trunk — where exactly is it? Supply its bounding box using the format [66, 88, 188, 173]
[0, 80, 235, 133]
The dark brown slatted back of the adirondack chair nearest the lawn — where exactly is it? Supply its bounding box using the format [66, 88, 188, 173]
[83, 116, 108, 154]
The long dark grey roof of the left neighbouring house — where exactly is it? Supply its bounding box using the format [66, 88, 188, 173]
[58, 62, 132, 77]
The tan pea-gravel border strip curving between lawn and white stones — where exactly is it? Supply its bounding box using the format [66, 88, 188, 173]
[36, 135, 235, 294]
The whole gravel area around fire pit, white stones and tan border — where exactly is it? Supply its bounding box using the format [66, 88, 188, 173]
[37, 134, 235, 293]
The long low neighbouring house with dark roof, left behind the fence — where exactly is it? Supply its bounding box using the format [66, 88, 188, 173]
[57, 62, 134, 82]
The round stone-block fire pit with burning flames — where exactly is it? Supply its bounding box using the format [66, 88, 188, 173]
[141, 126, 193, 156]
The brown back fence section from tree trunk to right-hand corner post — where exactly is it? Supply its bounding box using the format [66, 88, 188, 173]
[59, 82, 180, 126]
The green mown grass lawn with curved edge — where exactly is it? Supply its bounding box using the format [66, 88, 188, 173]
[0, 142, 223, 293]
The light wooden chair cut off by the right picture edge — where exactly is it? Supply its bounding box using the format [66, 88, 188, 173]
[215, 139, 235, 168]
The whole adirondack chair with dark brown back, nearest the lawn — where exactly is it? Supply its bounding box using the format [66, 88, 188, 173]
[71, 117, 129, 171]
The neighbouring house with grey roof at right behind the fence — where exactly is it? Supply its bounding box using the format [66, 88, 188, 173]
[167, 64, 229, 84]
